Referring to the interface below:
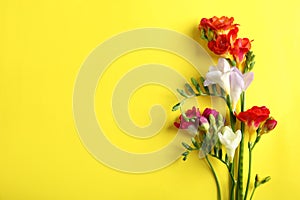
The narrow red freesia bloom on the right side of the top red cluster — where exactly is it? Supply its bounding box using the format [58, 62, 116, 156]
[230, 38, 251, 65]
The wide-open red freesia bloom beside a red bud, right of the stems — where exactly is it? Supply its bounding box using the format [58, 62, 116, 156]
[236, 106, 270, 129]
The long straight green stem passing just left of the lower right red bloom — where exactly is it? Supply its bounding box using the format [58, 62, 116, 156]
[237, 92, 245, 200]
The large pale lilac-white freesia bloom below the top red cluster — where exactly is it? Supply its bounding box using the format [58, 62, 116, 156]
[204, 58, 254, 110]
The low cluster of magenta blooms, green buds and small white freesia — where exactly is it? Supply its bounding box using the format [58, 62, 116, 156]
[174, 107, 241, 163]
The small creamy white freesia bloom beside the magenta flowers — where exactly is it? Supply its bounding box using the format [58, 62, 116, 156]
[218, 126, 242, 162]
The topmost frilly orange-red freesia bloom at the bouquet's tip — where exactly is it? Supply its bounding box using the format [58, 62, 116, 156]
[199, 16, 238, 31]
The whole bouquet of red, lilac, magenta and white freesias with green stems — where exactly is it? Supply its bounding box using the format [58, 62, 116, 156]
[173, 16, 277, 200]
